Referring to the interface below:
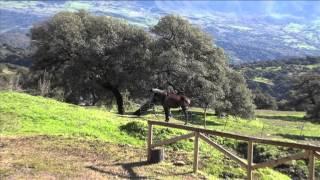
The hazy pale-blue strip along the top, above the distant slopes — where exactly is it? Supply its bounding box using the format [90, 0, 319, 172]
[0, 0, 320, 20]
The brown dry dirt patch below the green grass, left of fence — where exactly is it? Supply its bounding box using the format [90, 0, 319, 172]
[0, 136, 205, 179]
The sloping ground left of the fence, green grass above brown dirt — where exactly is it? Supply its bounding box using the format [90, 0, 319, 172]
[0, 92, 208, 179]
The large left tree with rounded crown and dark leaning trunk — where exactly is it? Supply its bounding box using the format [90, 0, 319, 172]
[31, 11, 150, 114]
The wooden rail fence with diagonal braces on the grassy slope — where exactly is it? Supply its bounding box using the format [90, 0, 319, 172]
[147, 121, 320, 180]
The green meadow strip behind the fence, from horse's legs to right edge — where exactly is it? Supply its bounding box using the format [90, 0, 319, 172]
[165, 108, 320, 144]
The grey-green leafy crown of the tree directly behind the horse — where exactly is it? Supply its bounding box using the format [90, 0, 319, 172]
[152, 15, 254, 118]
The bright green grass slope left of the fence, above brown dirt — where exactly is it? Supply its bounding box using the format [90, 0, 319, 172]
[0, 92, 144, 145]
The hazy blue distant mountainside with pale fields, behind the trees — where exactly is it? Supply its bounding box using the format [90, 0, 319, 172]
[0, 0, 320, 63]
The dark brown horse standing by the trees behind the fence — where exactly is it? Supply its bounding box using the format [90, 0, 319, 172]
[150, 88, 191, 125]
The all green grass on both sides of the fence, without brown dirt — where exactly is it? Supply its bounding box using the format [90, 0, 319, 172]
[0, 92, 320, 179]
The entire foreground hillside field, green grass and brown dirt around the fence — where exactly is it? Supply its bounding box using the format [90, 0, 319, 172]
[0, 92, 320, 179]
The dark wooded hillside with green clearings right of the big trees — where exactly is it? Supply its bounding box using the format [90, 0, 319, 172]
[234, 57, 320, 114]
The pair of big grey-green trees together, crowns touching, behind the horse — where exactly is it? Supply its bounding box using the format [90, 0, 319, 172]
[32, 11, 253, 117]
